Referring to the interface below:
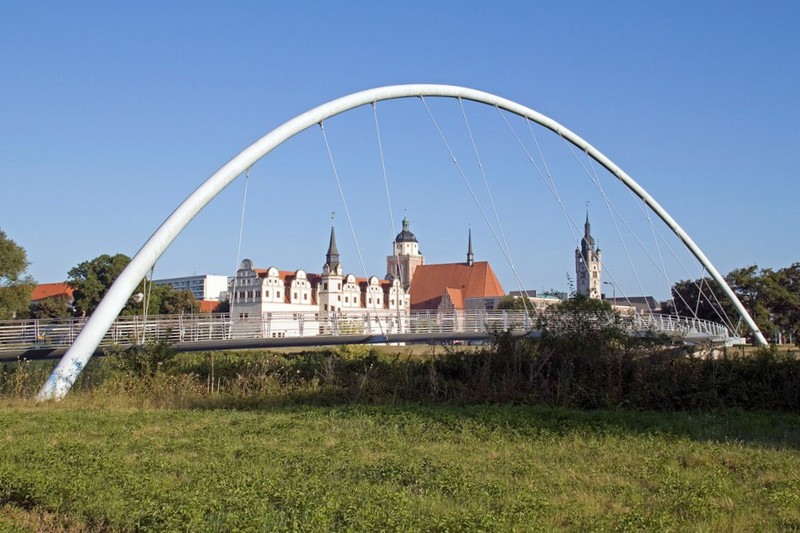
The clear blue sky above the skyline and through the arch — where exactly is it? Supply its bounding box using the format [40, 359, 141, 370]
[0, 1, 800, 296]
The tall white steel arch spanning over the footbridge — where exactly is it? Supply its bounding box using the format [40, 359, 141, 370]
[37, 84, 767, 400]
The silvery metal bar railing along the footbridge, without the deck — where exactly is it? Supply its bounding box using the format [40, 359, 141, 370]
[0, 310, 731, 352]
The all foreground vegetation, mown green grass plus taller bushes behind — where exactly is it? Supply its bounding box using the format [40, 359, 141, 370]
[0, 298, 800, 531]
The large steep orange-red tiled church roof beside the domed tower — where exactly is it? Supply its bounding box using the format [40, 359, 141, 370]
[409, 261, 505, 309]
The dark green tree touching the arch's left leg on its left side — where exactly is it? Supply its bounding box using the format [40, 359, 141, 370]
[67, 254, 133, 316]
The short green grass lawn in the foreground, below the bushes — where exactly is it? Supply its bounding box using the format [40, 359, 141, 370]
[0, 402, 800, 531]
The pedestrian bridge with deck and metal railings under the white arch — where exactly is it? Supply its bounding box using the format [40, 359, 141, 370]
[0, 310, 743, 360]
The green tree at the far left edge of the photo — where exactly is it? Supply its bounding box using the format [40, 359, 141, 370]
[0, 230, 36, 320]
